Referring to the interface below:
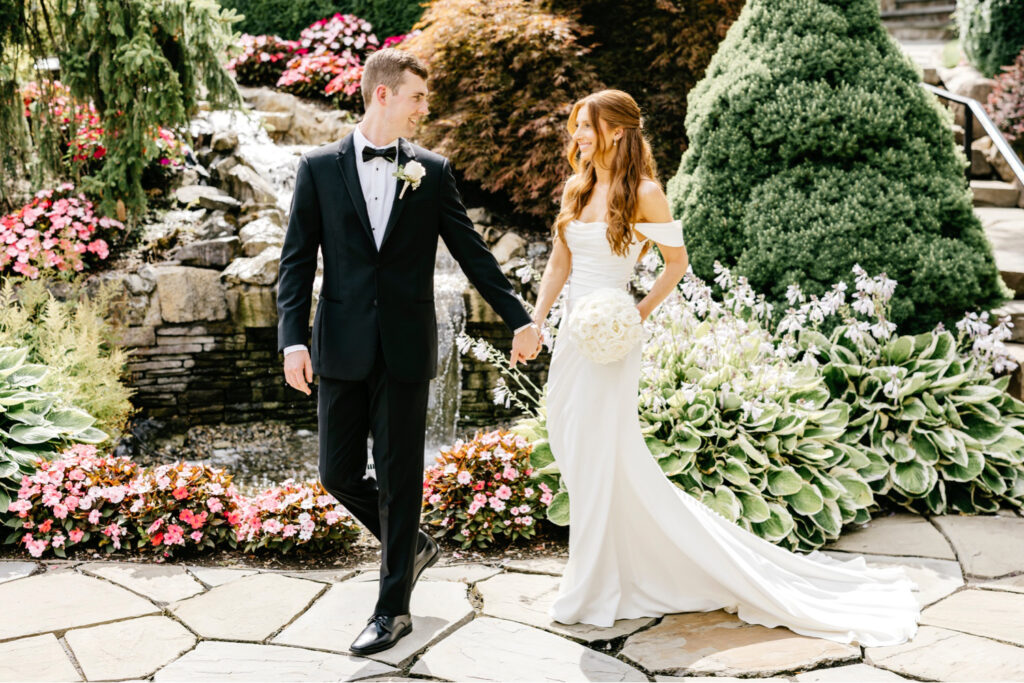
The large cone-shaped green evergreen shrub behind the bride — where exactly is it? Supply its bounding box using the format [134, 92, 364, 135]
[669, 0, 1006, 331]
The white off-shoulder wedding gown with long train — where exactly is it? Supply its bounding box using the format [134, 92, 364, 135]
[547, 221, 920, 646]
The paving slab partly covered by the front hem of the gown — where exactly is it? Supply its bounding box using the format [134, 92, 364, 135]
[476, 573, 654, 642]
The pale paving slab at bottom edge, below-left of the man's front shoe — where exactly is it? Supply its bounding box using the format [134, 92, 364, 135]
[154, 641, 394, 682]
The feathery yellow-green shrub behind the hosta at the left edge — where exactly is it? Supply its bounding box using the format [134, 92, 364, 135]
[0, 281, 134, 438]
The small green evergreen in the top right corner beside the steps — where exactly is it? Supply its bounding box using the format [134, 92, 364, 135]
[956, 0, 1024, 77]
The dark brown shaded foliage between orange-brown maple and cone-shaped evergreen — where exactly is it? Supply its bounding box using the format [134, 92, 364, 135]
[549, 0, 743, 180]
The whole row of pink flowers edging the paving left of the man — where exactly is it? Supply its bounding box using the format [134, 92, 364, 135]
[4, 444, 359, 558]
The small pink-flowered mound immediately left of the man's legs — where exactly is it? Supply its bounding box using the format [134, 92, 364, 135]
[234, 480, 359, 553]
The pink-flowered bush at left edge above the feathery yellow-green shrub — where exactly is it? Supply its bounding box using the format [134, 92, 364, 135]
[0, 182, 125, 280]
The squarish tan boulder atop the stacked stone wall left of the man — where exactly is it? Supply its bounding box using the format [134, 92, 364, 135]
[154, 265, 227, 323]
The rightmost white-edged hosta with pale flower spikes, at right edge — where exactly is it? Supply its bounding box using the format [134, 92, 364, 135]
[780, 267, 1024, 514]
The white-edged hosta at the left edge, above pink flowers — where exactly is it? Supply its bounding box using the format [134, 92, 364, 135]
[0, 346, 106, 511]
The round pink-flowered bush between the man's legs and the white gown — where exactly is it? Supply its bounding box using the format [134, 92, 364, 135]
[423, 430, 553, 548]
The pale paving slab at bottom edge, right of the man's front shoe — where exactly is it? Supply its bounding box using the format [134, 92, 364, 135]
[410, 616, 647, 681]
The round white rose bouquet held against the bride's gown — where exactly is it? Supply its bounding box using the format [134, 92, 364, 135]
[565, 288, 644, 365]
